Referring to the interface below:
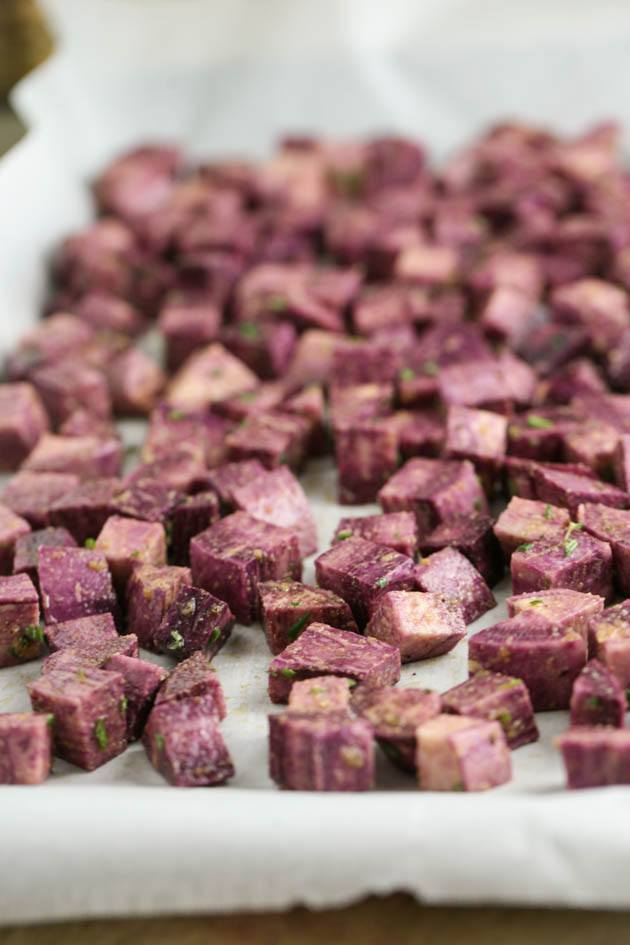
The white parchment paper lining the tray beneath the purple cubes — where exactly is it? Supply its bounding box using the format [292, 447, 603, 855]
[0, 0, 630, 923]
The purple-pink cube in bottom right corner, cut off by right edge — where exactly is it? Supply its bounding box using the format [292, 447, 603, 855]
[556, 725, 630, 789]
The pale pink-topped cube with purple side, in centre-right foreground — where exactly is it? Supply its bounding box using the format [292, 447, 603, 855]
[365, 591, 466, 663]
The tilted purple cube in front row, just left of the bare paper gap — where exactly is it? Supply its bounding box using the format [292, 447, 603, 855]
[143, 699, 234, 787]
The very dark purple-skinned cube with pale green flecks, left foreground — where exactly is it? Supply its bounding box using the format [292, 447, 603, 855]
[153, 587, 234, 660]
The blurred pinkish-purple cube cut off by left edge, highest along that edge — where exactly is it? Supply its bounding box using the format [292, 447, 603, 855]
[0, 384, 48, 470]
